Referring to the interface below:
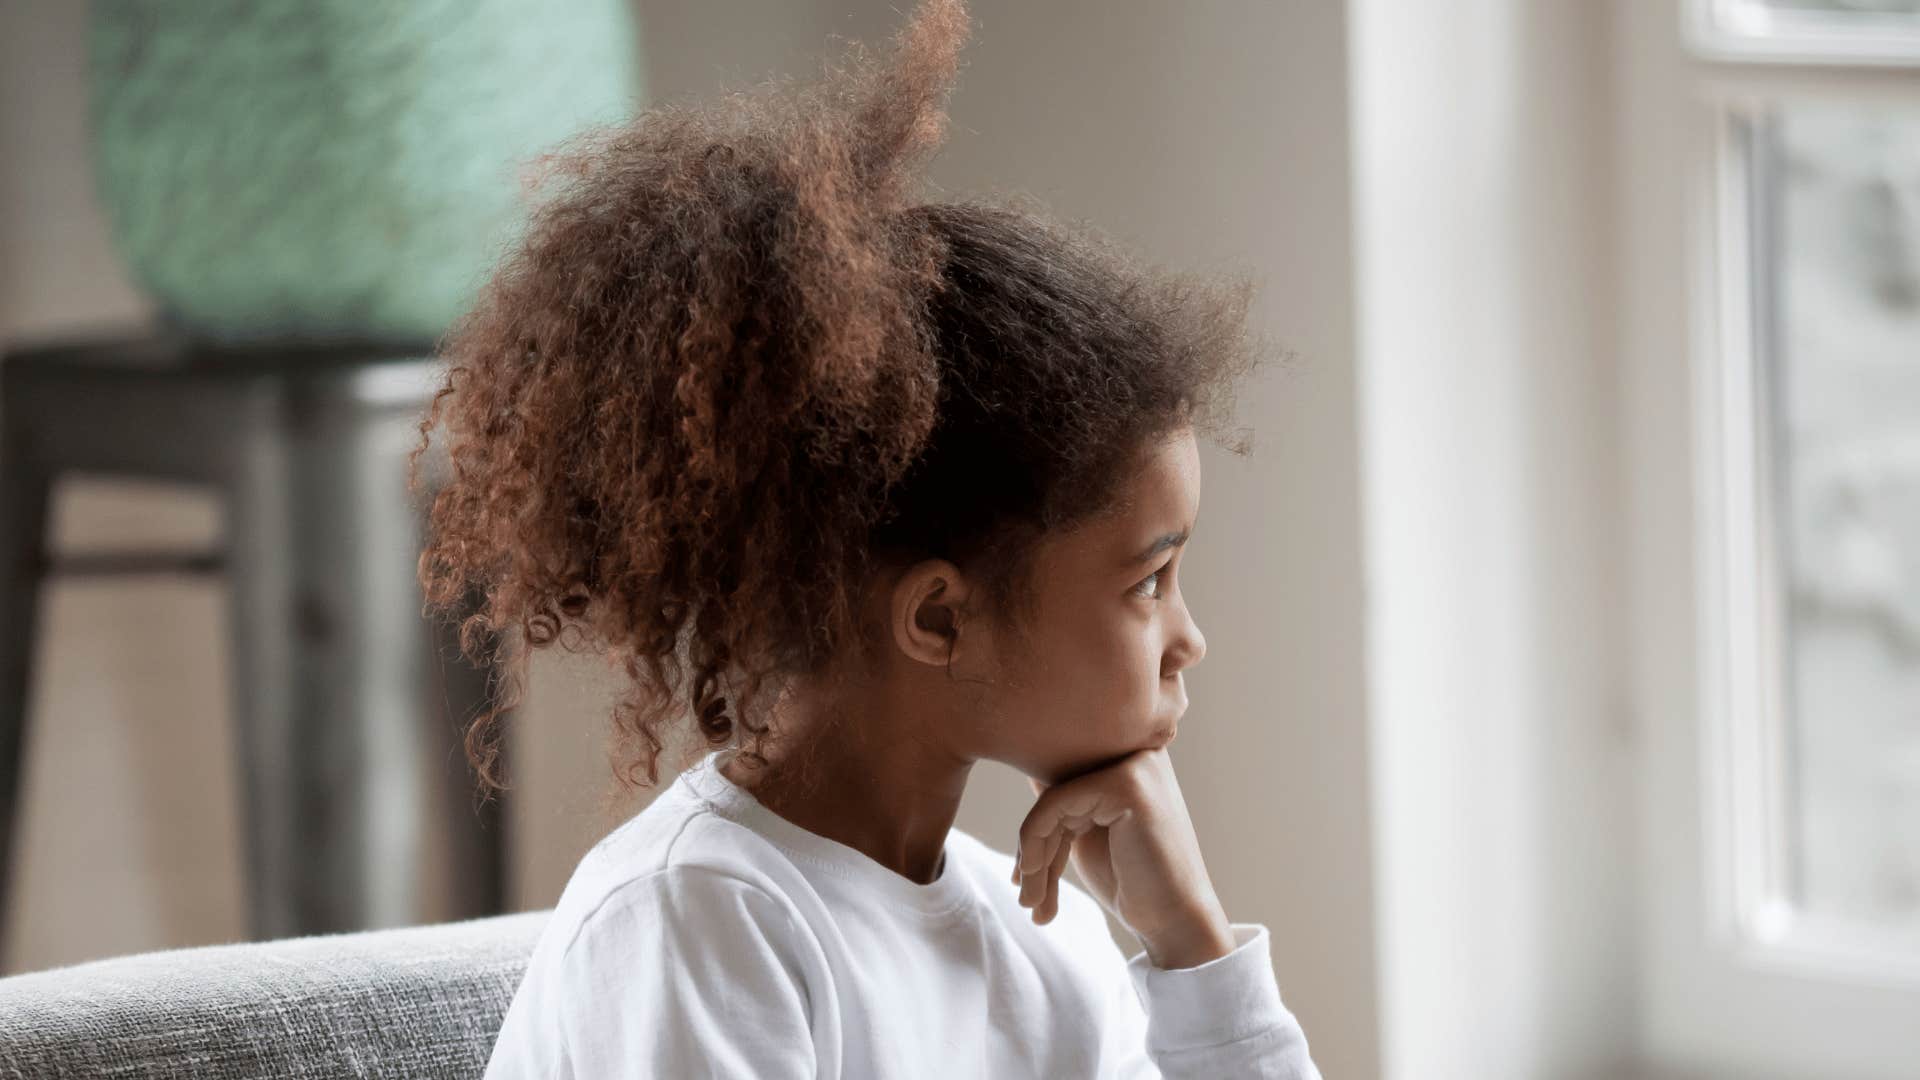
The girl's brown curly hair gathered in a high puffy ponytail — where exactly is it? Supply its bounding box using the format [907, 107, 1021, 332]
[413, 0, 1261, 792]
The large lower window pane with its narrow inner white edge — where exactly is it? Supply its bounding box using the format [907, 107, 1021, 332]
[1705, 98, 1920, 974]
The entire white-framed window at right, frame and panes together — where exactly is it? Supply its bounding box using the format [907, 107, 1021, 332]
[1615, 0, 1920, 1080]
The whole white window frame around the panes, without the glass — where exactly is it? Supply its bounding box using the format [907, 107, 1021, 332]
[1615, 0, 1920, 1080]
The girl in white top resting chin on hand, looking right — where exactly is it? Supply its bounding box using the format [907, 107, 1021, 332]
[420, 0, 1319, 1080]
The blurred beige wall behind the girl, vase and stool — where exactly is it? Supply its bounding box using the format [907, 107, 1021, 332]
[0, 0, 1379, 1076]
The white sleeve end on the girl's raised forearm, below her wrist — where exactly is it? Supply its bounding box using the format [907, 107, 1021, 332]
[1119, 922, 1321, 1080]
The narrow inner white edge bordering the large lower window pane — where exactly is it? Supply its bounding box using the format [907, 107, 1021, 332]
[1695, 100, 1920, 983]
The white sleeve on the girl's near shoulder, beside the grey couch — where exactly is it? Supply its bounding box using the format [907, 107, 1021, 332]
[557, 867, 814, 1080]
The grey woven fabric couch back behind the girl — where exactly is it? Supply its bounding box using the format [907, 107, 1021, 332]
[0, 909, 553, 1080]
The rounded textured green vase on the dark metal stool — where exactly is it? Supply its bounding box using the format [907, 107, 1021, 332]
[90, 0, 639, 342]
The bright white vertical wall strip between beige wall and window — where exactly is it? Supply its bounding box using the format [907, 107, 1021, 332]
[1352, 0, 1632, 1080]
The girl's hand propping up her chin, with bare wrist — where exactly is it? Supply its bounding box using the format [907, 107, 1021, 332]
[1014, 748, 1233, 969]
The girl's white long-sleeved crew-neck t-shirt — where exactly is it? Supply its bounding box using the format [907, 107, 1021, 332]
[486, 751, 1319, 1080]
